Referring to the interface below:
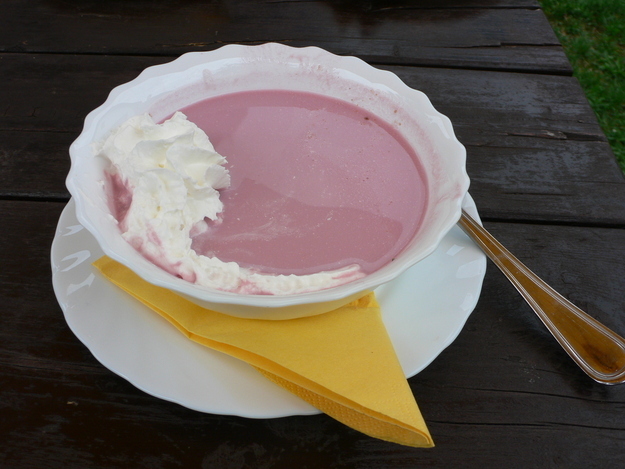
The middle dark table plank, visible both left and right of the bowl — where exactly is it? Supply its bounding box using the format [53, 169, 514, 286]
[0, 54, 625, 225]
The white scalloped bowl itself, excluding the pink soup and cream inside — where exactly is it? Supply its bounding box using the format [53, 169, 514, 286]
[67, 43, 469, 319]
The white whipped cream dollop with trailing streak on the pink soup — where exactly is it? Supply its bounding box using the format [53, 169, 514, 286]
[94, 112, 364, 295]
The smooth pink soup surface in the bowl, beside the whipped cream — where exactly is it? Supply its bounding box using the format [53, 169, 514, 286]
[181, 90, 427, 275]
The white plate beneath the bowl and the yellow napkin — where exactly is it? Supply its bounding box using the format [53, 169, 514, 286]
[52, 195, 486, 418]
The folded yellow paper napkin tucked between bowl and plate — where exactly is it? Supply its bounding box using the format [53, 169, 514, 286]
[94, 256, 434, 447]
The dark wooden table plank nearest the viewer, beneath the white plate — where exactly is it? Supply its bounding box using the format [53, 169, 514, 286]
[0, 201, 625, 468]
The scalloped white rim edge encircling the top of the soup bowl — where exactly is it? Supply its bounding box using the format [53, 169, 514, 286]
[66, 43, 470, 308]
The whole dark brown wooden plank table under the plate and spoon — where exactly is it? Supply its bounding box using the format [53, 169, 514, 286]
[0, 0, 625, 468]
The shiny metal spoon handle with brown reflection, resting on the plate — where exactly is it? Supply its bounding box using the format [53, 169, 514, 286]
[458, 210, 625, 384]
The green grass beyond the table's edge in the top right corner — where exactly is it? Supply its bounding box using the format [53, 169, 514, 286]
[540, 0, 625, 172]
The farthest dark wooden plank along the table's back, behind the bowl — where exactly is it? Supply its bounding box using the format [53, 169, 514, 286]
[0, 0, 571, 74]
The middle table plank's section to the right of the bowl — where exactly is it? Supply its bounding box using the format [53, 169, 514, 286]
[382, 67, 625, 225]
